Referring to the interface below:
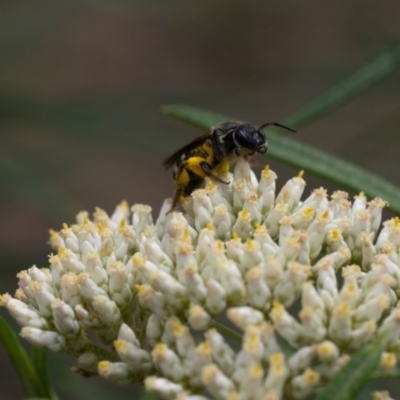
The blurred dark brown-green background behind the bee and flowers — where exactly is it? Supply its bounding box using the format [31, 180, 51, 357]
[0, 0, 400, 400]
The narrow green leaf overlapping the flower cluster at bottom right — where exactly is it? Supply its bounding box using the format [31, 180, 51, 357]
[315, 335, 386, 400]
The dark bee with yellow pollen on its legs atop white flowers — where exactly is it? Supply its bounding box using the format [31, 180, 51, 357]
[163, 122, 296, 211]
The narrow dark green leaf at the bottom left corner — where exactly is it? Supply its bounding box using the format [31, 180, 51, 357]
[0, 317, 46, 398]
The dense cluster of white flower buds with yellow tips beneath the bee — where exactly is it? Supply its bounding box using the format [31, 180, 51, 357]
[1, 161, 400, 400]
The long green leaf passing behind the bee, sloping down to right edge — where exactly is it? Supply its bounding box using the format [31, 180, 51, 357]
[162, 105, 400, 213]
